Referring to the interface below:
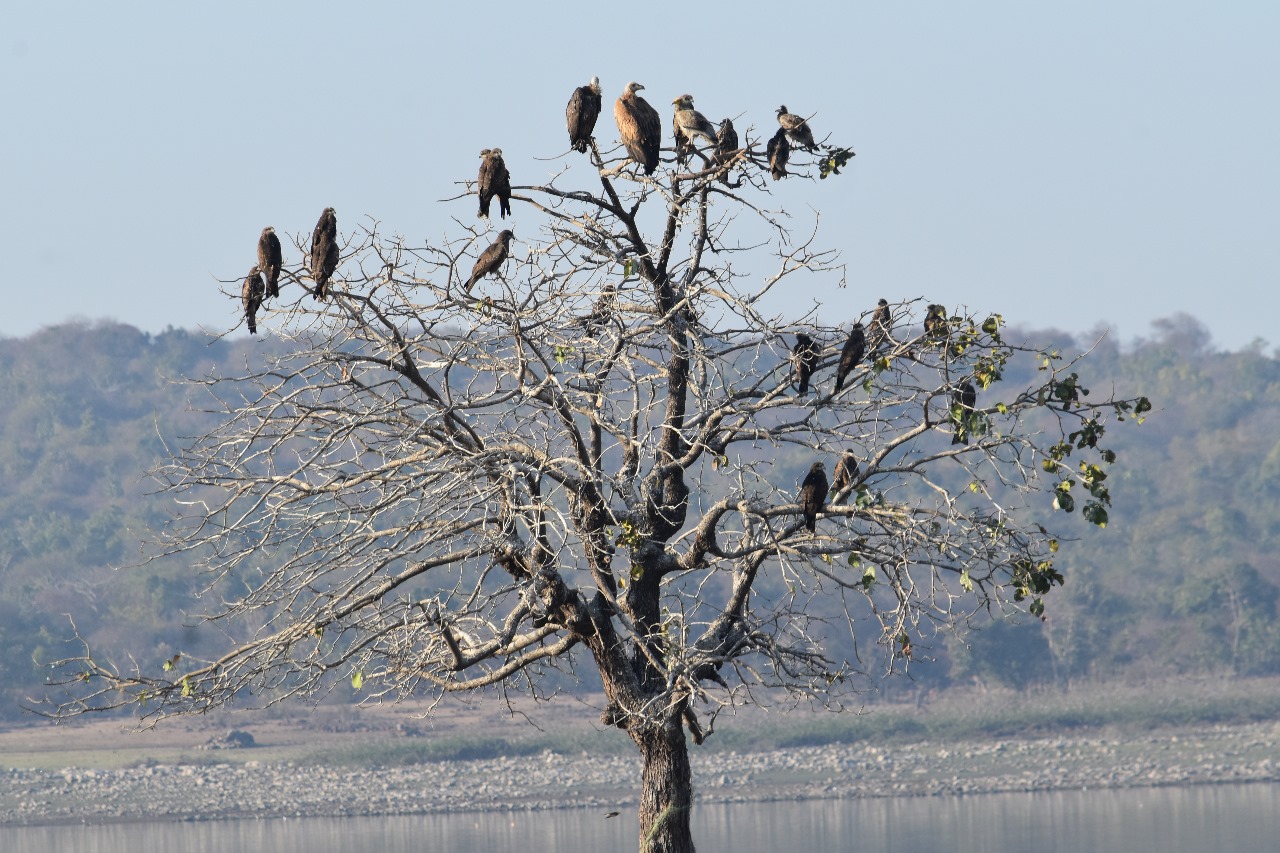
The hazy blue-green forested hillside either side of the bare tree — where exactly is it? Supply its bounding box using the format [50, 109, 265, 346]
[0, 316, 1280, 717]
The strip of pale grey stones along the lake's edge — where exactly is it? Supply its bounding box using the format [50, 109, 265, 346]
[0, 722, 1280, 825]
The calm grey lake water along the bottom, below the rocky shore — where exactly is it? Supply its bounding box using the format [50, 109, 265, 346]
[0, 784, 1280, 853]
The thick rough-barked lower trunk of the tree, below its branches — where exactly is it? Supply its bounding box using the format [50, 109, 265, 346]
[631, 715, 694, 853]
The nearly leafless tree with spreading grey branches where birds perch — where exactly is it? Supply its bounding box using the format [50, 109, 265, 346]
[50, 129, 1147, 853]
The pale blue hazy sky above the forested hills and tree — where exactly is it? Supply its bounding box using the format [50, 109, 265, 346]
[0, 0, 1280, 348]
